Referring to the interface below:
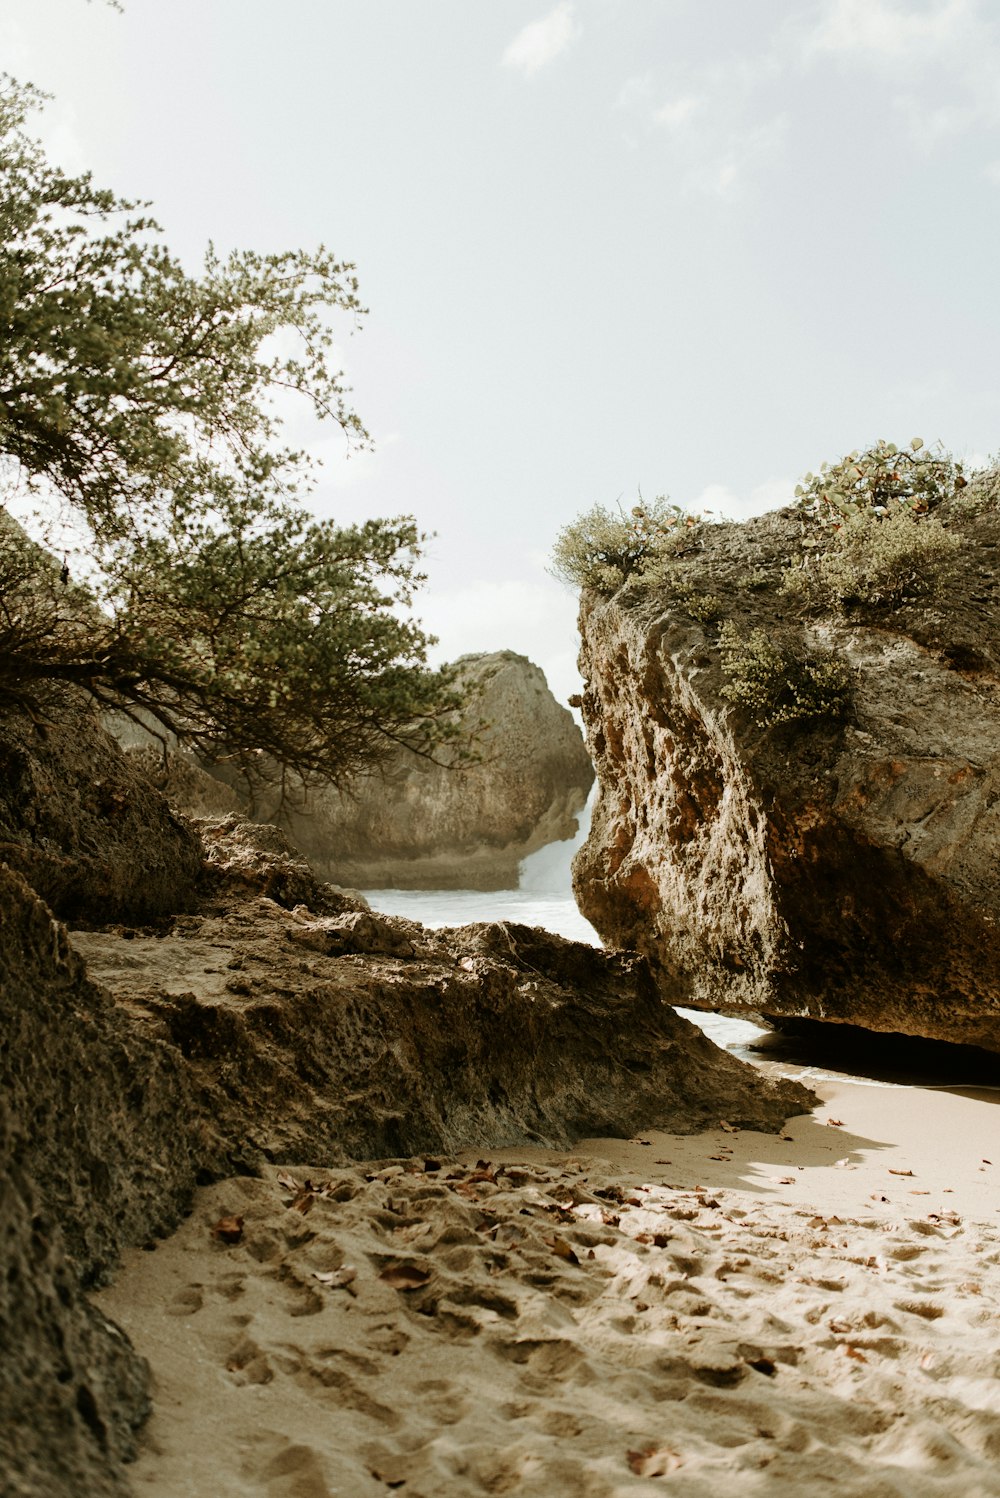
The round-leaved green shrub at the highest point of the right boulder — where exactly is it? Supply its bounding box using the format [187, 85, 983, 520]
[795, 437, 967, 526]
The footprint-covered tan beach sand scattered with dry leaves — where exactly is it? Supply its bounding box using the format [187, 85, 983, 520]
[99, 1083, 1000, 1498]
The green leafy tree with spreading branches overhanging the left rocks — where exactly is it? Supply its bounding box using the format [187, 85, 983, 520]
[0, 75, 458, 782]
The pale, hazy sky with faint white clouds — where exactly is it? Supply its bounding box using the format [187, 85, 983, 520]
[0, 0, 1000, 700]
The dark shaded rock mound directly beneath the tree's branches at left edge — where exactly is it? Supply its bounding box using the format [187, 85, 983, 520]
[0, 688, 201, 921]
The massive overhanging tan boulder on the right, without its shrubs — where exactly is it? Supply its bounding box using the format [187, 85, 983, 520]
[575, 491, 1000, 1050]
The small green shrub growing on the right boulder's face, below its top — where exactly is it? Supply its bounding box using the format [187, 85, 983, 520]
[719, 620, 850, 728]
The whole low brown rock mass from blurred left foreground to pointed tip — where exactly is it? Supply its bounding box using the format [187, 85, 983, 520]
[0, 704, 813, 1498]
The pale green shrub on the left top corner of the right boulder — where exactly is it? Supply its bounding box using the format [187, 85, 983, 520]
[552, 496, 701, 593]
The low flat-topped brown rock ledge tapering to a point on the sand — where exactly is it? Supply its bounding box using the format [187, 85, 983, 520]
[73, 880, 811, 1168]
